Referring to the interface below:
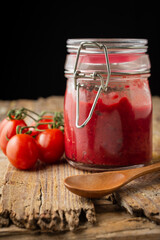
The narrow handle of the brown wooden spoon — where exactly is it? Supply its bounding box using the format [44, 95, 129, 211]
[125, 162, 160, 180]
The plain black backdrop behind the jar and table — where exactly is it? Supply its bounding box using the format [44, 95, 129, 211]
[0, 1, 160, 99]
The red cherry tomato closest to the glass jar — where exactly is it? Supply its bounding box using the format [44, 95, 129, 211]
[36, 128, 64, 163]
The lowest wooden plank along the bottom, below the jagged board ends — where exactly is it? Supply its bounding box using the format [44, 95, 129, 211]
[0, 201, 160, 240]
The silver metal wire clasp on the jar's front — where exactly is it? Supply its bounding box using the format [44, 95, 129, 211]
[74, 42, 111, 128]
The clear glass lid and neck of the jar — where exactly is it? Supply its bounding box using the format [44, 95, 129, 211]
[64, 38, 151, 77]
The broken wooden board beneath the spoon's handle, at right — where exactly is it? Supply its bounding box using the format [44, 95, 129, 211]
[114, 173, 160, 224]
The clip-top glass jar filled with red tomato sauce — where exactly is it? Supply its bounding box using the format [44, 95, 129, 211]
[64, 39, 152, 171]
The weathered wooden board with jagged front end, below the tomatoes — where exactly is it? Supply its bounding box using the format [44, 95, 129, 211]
[0, 163, 95, 231]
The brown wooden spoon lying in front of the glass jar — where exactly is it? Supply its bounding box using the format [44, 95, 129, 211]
[64, 162, 160, 198]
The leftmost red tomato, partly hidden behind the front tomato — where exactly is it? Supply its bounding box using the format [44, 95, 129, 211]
[0, 120, 27, 154]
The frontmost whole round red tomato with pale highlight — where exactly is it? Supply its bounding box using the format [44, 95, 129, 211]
[6, 134, 38, 170]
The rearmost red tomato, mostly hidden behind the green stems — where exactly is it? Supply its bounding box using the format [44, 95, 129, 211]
[29, 115, 53, 136]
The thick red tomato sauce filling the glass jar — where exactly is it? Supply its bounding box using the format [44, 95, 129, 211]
[64, 83, 152, 167]
